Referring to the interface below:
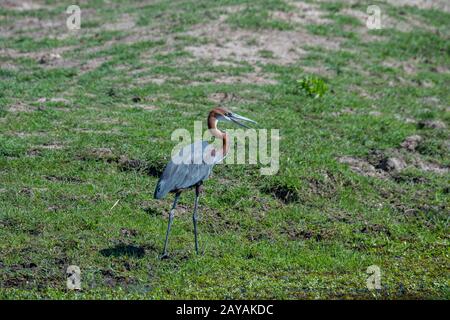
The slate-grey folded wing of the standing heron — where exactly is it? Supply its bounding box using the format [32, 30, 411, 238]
[154, 141, 214, 199]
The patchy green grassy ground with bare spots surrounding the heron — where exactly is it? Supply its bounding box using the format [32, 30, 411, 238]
[0, 0, 450, 299]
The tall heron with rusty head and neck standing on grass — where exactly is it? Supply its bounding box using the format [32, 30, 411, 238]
[154, 107, 256, 259]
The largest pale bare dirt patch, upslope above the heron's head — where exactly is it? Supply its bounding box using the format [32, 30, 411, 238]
[185, 2, 340, 73]
